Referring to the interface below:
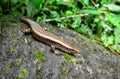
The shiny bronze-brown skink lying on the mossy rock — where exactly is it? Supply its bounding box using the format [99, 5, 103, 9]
[21, 17, 80, 54]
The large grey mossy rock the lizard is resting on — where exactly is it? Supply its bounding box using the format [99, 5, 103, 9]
[0, 15, 120, 79]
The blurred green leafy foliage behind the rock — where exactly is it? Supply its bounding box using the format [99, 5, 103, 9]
[0, 0, 120, 54]
